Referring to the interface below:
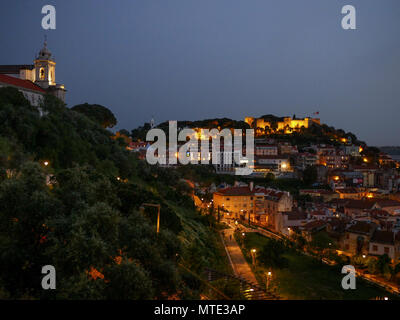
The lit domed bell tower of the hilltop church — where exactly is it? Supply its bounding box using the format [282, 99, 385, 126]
[35, 40, 56, 89]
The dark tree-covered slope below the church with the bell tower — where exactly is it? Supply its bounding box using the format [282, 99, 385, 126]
[0, 88, 231, 299]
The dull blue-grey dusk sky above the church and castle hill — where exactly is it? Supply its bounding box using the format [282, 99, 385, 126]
[0, 0, 400, 146]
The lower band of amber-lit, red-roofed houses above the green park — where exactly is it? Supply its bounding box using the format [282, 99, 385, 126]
[208, 182, 400, 261]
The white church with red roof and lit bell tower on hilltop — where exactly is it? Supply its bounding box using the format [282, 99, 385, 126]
[0, 41, 66, 106]
